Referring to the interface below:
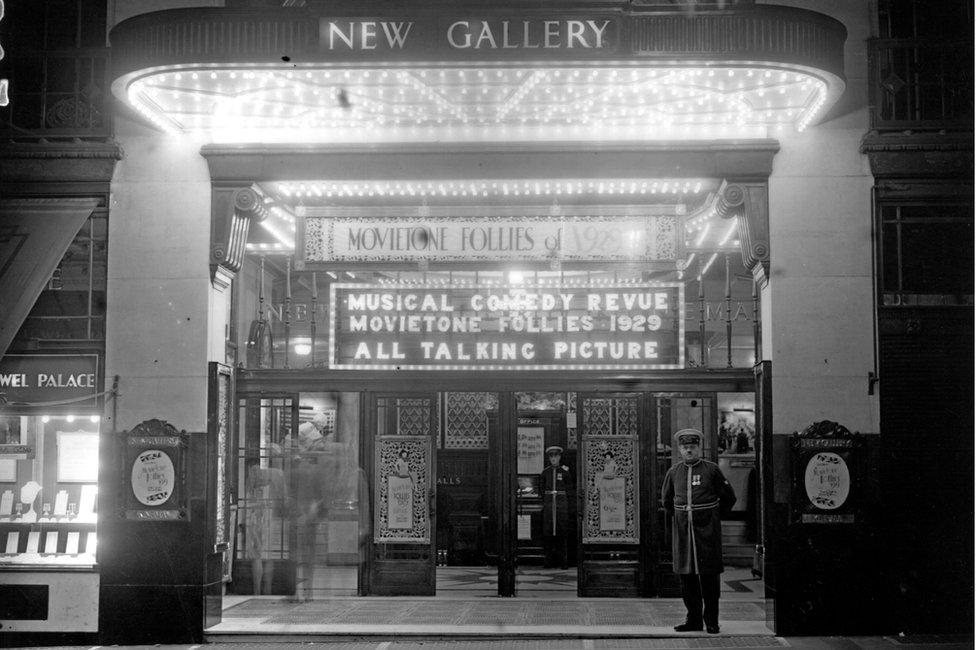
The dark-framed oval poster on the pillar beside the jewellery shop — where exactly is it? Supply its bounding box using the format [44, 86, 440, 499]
[119, 420, 189, 521]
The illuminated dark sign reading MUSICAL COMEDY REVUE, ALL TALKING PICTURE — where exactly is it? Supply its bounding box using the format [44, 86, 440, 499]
[329, 283, 685, 370]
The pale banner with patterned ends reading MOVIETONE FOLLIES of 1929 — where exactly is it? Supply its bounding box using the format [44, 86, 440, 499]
[298, 215, 680, 263]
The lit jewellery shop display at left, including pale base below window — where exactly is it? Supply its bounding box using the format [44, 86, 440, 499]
[0, 415, 99, 632]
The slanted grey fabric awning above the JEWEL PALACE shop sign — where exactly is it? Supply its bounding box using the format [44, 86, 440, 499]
[0, 198, 97, 354]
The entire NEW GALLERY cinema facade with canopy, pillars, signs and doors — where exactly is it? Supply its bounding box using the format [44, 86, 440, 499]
[0, 2, 971, 642]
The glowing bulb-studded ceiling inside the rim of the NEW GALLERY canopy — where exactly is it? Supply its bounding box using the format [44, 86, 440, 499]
[128, 67, 826, 136]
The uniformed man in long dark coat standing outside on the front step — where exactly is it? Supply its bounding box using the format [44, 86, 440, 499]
[661, 429, 735, 634]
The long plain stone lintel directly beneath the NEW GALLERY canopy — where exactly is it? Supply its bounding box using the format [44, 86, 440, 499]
[201, 140, 779, 185]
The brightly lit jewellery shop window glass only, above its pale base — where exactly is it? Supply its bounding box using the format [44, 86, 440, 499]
[0, 415, 99, 568]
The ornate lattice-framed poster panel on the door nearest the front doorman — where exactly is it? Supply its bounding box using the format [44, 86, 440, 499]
[582, 435, 640, 544]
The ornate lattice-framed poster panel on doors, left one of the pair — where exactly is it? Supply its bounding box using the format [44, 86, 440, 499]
[373, 435, 432, 544]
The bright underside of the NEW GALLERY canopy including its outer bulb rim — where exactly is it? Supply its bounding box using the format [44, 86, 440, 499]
[116, 64, 828, 142]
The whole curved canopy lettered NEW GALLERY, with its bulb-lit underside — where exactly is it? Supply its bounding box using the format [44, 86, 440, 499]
[111, 3, 846, 143]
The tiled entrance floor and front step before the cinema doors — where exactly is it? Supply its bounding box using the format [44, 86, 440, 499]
[207, 567, 772, 641]
